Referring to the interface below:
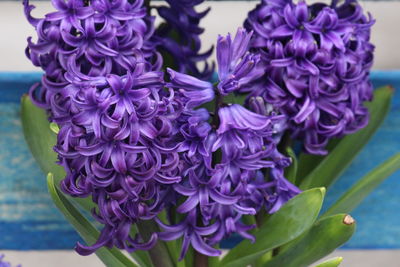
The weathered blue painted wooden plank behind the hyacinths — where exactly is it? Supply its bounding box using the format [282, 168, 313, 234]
[0, 71, 400, 250]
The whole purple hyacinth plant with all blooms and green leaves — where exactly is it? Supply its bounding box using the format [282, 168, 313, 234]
[21, 0, 400, 267]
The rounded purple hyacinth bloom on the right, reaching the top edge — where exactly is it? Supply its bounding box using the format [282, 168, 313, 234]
[245, 0, 374, 154]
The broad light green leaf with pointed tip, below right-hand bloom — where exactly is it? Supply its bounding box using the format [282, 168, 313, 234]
[220, 188, 325, 267]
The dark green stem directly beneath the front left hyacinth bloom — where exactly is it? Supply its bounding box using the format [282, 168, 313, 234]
[137, 220, 174, 267]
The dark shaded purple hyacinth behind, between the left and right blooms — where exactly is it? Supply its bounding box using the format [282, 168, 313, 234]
[152, 0, 214, 79]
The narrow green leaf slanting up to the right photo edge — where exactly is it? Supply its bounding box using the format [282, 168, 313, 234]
[323, 153, 400, 216]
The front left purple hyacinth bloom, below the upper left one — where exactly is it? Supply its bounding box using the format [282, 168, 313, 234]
[55, 71, 181, 255]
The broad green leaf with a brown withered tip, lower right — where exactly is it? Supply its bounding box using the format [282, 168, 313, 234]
[264, 214, 356, 267]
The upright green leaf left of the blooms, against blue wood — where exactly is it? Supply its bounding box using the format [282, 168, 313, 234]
[21, 95, 65, 183]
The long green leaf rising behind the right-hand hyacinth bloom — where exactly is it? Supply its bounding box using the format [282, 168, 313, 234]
[300, 87, 393, 190]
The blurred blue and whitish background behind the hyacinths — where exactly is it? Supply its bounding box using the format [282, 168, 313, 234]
[0, 0, 400, 267]
